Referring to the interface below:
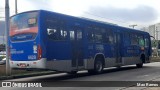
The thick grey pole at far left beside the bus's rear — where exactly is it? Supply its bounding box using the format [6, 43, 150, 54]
[5, 0, 11, 76]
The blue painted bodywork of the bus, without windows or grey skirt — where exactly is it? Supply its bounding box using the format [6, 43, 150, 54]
[10, 10, 151, 64]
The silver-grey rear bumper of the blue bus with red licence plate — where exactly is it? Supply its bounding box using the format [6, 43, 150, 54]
[10, 58, 46, 69]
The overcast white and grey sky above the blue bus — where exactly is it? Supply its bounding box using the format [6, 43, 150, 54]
[0, 0, 160, 28]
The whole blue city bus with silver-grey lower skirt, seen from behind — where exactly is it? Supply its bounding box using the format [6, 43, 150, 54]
[9, 10, 151, 73]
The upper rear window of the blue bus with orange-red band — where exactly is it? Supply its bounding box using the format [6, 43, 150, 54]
[10, 12, 38, 42]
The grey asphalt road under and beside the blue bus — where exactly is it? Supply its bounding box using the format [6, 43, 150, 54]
[0, 62, 160, 90]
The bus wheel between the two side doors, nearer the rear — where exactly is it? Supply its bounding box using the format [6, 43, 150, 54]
[94, 58, 104, 73]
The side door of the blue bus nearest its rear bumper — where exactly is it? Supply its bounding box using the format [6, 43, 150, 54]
[70, 27, 84, 70]
